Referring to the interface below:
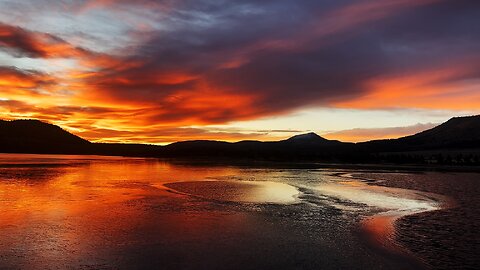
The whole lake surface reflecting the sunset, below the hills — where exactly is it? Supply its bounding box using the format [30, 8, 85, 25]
[0, 154, 480, 269]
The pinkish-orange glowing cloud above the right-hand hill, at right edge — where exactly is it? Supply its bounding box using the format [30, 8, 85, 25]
[334, 56, 480, 110]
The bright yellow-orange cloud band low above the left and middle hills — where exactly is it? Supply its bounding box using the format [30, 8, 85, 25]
[0, 100, 292, 144]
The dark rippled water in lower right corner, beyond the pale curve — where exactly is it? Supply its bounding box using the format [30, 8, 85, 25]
[352, 171, 480, 269]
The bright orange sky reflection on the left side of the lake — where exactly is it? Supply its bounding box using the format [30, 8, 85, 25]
[0, 154, 245, 269]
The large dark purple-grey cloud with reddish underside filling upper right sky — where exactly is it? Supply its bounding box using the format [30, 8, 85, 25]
[77, 0, 480, 122]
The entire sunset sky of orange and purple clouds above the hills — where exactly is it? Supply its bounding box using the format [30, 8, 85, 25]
[0, 0, 480, 144]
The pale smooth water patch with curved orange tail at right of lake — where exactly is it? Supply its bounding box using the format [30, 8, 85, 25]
[316, 173, 447, 258]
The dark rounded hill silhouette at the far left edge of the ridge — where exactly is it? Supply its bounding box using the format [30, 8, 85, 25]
[0, 120, 90, 153]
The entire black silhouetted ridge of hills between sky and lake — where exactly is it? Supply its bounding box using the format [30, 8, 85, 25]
[0, 116, 480, 162]
